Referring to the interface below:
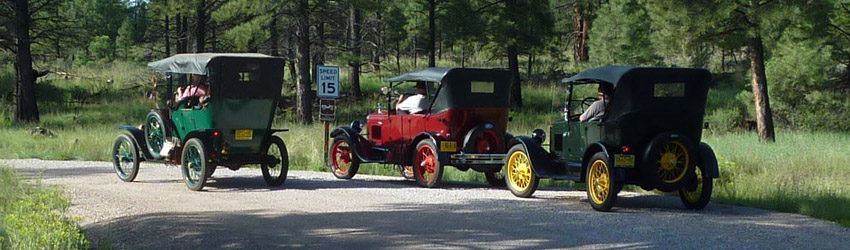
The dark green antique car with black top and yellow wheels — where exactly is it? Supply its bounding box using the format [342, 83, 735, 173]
[505, 66, 719, 211]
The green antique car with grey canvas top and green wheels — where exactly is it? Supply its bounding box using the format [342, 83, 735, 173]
[112, 53, 289, 191]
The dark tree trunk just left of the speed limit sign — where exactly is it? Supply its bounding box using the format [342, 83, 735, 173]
[296, 0, 313, 124]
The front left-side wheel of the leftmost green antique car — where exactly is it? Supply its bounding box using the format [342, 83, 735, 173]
[112, 134, 140, 182]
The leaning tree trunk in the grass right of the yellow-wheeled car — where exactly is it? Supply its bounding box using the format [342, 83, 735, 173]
[748, 34, 776, 142]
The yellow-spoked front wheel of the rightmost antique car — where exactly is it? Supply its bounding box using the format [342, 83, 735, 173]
[505, 144, 540, 198]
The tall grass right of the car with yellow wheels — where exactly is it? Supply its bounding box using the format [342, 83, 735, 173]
[705, 132, 850, 226]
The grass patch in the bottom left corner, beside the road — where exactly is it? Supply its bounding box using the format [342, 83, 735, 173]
[0, 166, 89, 249]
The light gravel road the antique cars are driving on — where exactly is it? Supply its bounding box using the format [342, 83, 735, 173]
[0, 160, 850, 249]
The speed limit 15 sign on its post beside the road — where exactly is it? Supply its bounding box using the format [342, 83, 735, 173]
[316, 65, 342, 164]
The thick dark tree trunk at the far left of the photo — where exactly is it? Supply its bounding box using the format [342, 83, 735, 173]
[12, 0, 39, 122]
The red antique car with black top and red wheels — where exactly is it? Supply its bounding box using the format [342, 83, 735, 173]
[328, 68, 512, 187]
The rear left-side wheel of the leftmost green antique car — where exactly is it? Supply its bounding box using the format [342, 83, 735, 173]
[180, 138, 210, 191]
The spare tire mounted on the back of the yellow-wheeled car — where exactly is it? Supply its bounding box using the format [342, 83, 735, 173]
[640, 133, 698, 192]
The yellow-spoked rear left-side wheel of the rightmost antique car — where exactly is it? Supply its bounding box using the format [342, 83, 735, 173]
[585, 152, 623, 212]
